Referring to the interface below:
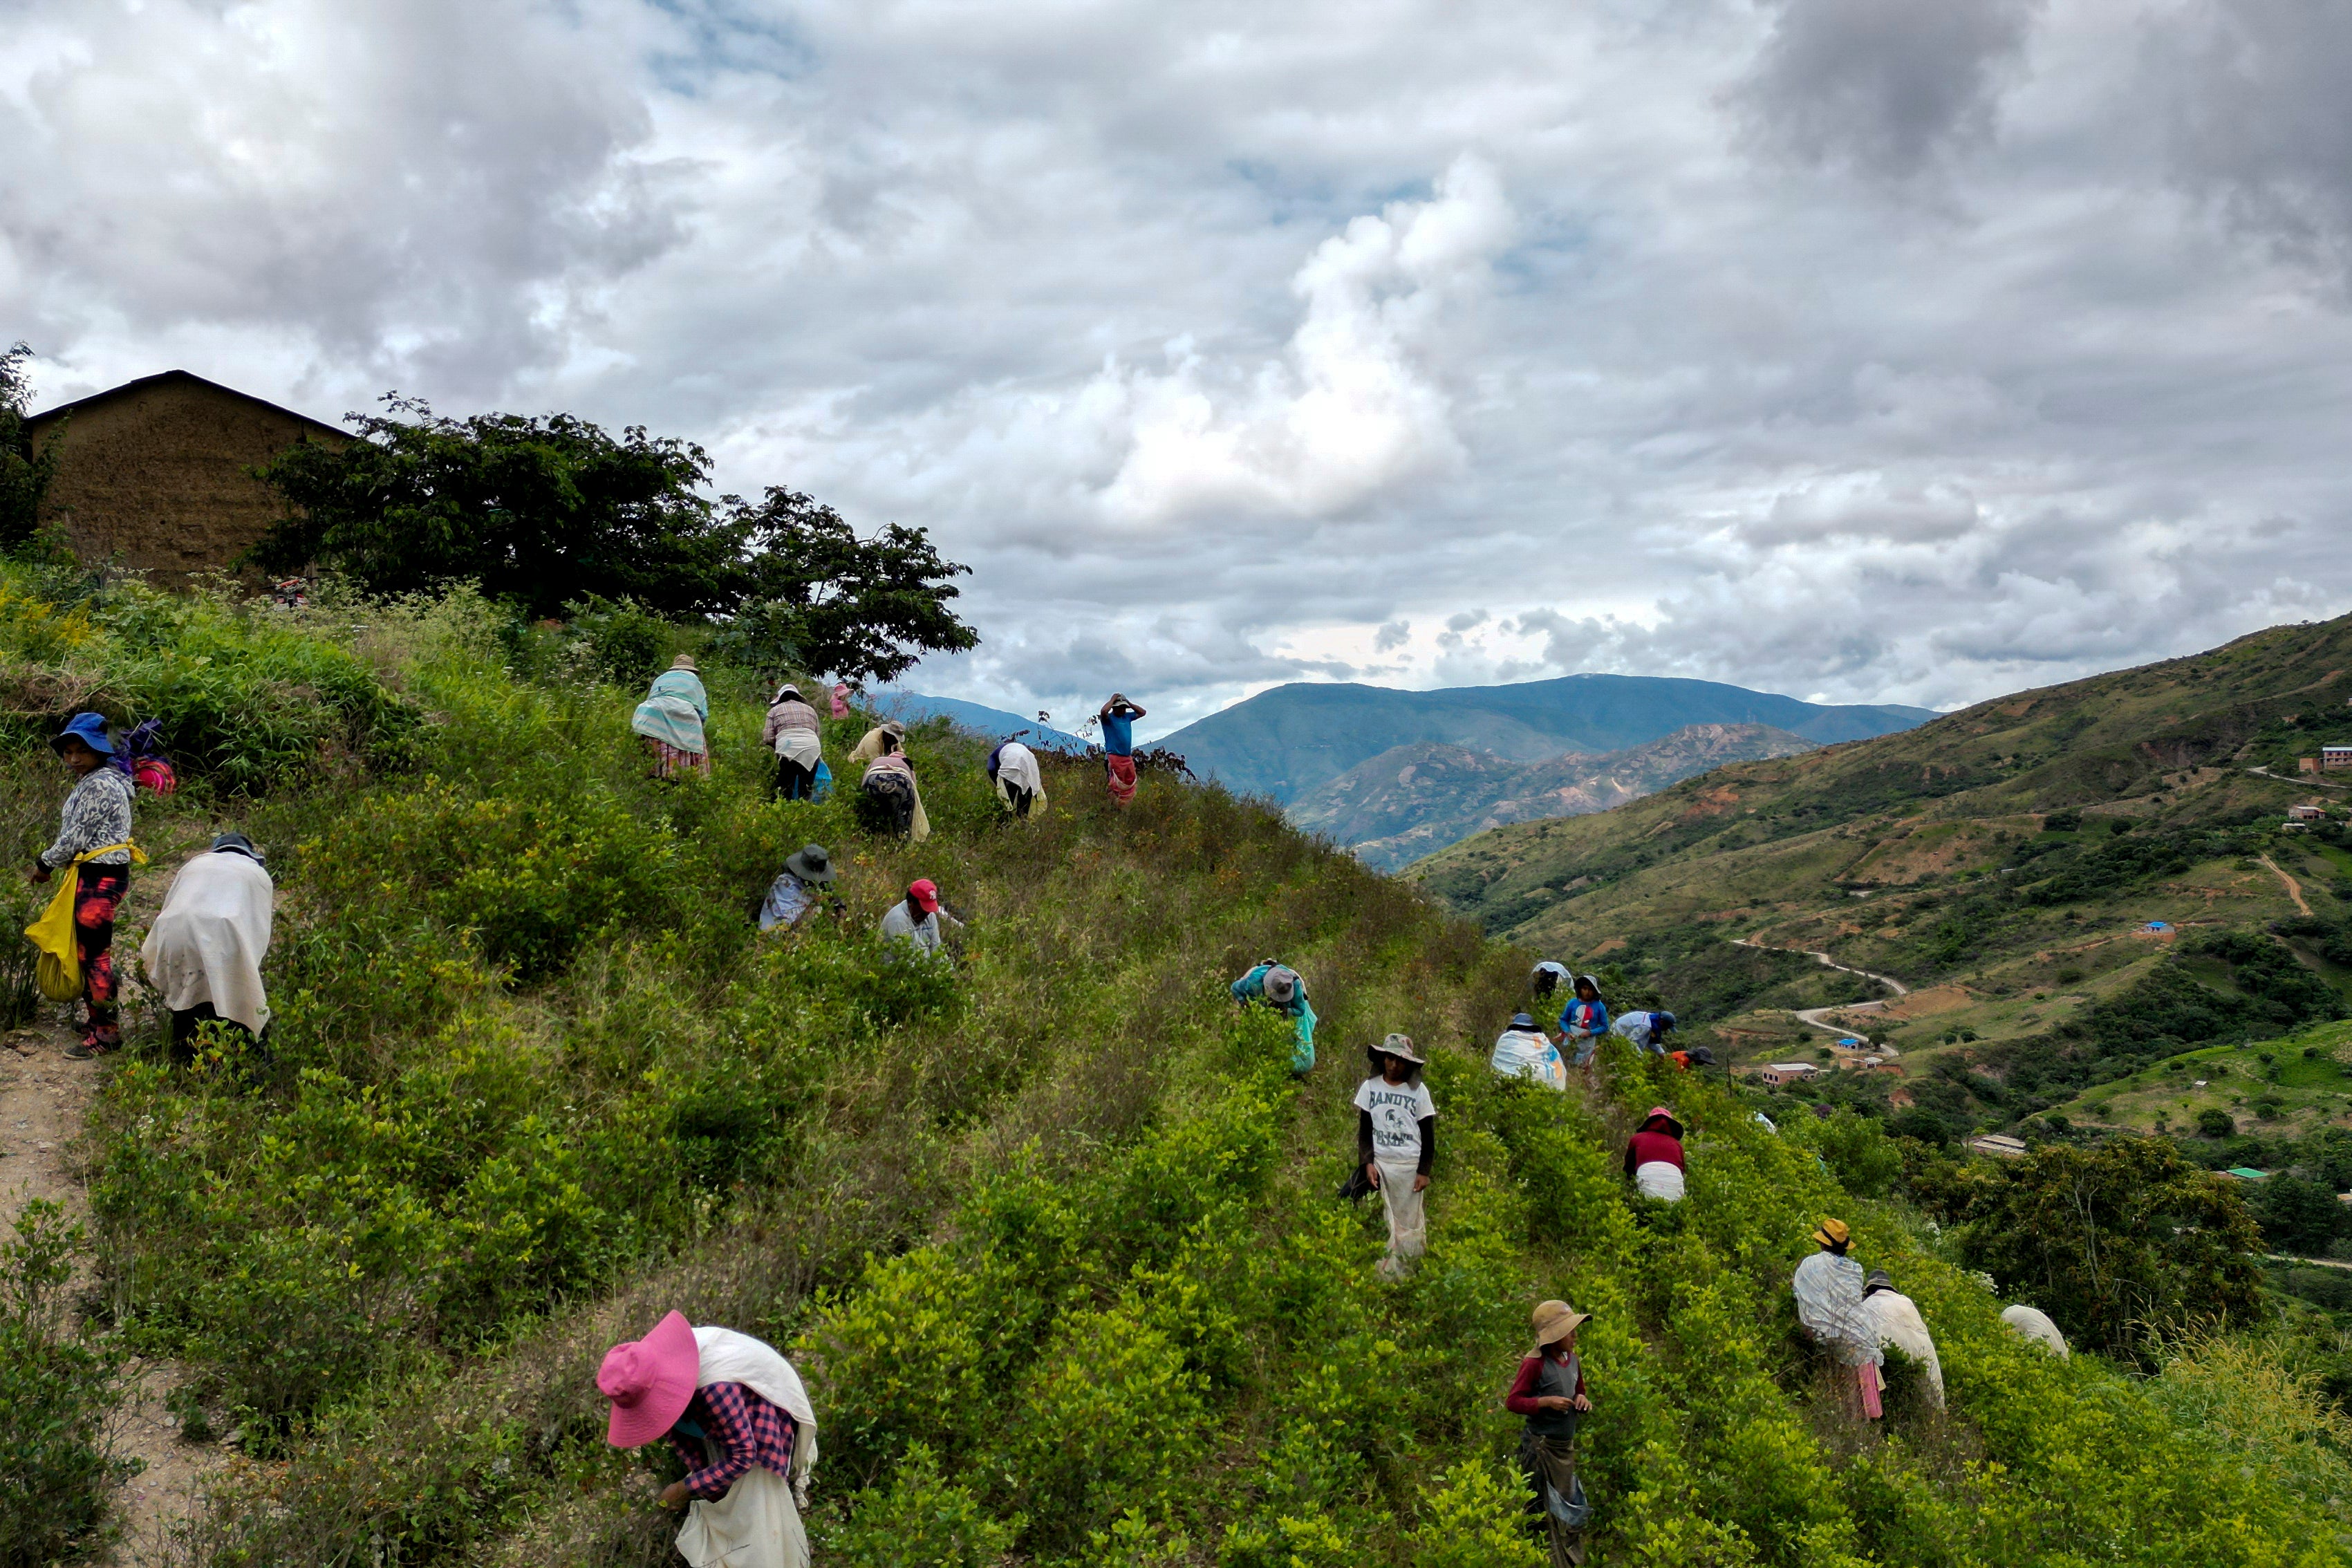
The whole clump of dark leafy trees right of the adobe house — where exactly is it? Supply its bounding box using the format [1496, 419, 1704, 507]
[250, 395, 978, 680]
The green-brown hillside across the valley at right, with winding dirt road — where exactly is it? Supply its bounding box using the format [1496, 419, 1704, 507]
[1411, 621, 2352, 1131]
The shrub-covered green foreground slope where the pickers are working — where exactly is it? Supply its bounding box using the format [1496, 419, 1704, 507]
[0, 569, 2352, 1568]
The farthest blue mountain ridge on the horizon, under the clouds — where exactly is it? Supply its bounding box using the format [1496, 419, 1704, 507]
[1162, 675, 1936, 802]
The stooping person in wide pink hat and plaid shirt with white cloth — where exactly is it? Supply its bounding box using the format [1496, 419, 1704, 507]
[595, 1312, 816, 1568]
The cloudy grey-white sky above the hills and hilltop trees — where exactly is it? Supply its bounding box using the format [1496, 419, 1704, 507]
[0, 0, 2352, 729]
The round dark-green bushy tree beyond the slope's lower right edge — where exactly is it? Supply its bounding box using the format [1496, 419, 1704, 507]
[1914, 1138, 2263, 1352]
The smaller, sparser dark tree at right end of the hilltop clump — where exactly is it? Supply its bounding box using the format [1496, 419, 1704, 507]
[720, 484, 978, 682]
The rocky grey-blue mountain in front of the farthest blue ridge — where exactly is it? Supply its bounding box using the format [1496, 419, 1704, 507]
[1284, 724, 1816, 870]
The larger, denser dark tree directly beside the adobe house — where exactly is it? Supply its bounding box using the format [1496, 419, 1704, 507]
[252, 395, 741, 616]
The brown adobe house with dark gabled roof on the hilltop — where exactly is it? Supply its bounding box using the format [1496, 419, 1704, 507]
[24, 369, 351, 586]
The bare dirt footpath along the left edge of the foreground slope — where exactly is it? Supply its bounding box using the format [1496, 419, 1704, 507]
[0, 856, 230, 1568]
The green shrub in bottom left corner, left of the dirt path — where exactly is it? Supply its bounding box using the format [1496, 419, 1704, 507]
[0, 1199, 122, 1568]
